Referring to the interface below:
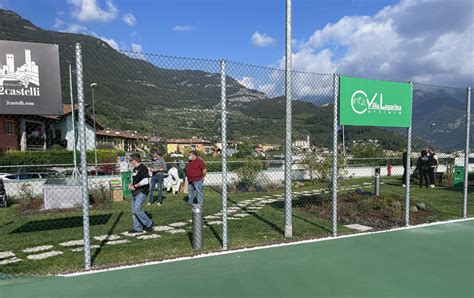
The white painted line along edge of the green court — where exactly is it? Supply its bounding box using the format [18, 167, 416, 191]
[62, 217, 474, 277]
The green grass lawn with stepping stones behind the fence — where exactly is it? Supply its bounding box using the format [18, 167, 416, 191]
[0, 178, 474, 275]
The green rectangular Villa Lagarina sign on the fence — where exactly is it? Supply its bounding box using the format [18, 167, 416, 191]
[339, 77, 412, 127]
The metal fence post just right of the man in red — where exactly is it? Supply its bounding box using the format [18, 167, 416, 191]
[221, 60, 227, 250]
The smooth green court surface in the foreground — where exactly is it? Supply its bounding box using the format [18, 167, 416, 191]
[0, 220, 474, 298]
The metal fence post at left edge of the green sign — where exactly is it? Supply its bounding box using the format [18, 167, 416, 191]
[332, 74, 339, 237]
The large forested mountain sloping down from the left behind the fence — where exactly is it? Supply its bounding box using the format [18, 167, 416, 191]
[0, 10, 404, 149]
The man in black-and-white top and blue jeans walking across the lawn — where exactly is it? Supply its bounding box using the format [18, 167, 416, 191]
[128, 153, 153, 234]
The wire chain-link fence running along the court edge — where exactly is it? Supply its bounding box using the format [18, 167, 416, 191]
[0, 43, 474, 279]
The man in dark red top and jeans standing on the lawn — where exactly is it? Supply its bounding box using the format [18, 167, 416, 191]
[186, 150, 207, 207]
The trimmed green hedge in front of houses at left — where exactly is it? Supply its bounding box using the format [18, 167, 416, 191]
[0, 149, 124, 166]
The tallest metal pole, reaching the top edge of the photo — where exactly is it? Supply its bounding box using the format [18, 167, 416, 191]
[285, 0, 293, 237]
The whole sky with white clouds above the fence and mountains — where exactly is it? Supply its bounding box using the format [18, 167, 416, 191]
[0, 0, 474, 87]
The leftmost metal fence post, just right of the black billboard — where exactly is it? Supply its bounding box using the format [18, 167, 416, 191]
[76, 43, 91, 270]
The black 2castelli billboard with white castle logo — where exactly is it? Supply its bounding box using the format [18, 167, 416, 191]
[0, 40, 63, 115]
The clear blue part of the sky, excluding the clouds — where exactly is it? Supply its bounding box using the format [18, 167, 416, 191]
[3, 0, 397, 65]
